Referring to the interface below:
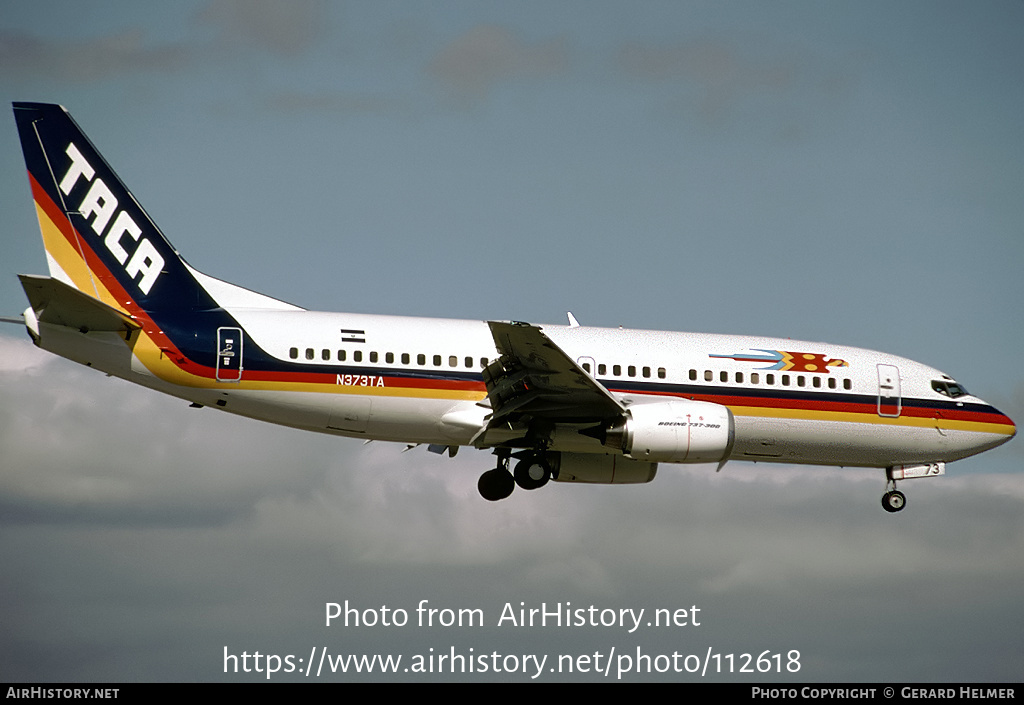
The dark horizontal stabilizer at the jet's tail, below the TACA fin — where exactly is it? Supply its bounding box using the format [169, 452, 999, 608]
[18, 275, 141, 337]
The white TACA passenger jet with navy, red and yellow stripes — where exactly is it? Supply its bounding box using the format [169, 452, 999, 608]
[14, 102, 1016, 511]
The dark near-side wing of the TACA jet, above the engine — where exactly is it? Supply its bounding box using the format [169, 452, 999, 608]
[483, 321, 626, 428]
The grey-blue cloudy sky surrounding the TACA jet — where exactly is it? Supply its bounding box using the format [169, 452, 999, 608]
[0, 0, 1024, 680]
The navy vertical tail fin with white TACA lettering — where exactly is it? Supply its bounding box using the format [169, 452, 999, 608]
[14, 102, 294, 315]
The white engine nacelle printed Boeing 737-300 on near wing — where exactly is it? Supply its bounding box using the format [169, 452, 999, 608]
[605, 400, 736, 463]
